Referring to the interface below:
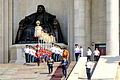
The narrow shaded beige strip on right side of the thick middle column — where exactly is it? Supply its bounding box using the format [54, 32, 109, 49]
[84, 0, 92, 56]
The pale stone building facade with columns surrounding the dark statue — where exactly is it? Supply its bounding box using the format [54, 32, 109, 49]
[0, 0, 119, 63]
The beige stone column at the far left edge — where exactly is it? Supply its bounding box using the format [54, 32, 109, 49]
[0, 0, 9, 63]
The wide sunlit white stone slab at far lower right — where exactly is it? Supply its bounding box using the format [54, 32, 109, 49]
[91, 56, 120, 80]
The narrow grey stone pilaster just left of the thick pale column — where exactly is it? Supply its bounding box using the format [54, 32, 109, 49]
[66, 0, 74, 60]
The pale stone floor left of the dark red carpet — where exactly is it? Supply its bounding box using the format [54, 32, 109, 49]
[0, 63, 60, 80]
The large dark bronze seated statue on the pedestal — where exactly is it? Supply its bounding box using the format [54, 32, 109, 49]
[15, 5, 64, 44]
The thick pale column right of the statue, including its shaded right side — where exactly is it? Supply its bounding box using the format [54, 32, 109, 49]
[74, 0, 91, 56]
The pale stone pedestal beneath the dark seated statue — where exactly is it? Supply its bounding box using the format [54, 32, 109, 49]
[9, 43, 67, 63]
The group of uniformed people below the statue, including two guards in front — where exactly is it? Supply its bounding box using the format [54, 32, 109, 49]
[24, 44, 69, 77]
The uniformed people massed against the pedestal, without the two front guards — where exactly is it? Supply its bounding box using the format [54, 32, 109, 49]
[24, 44, 69, 63]
